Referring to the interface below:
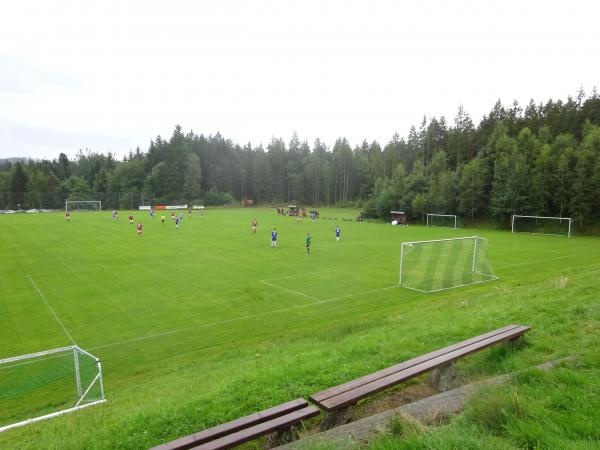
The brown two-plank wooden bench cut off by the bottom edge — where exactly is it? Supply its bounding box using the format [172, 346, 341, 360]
[153, 398, 320, 450]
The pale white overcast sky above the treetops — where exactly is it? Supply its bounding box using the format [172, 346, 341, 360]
[0, 0, 600, 158]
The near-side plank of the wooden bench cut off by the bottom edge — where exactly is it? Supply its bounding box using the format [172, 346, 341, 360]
[193, 406, 321, 450]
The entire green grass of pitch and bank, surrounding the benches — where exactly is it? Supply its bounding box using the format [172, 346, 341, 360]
[0, 210, 600, 449]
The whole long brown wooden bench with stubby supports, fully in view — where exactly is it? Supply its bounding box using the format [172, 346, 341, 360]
[310, 325, 530, 430]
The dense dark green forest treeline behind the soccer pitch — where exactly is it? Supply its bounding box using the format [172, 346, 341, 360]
[0, 90, 600, 226]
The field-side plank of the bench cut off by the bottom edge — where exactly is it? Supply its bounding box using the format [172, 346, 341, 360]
[152, 398, 308, 450]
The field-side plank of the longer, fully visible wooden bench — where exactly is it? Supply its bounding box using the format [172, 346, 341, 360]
[309, 325, 519, 404]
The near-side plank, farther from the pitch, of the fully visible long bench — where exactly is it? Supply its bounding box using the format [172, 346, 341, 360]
[316, 326, 530, 412]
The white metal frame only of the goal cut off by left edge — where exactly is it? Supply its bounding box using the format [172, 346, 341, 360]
[0, 345, 106, 433]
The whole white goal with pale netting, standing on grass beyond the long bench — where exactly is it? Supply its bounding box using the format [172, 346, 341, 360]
[399, 236, 498, 292]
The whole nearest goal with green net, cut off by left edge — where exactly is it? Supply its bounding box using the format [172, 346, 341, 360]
[0, 345, 105, 432]
